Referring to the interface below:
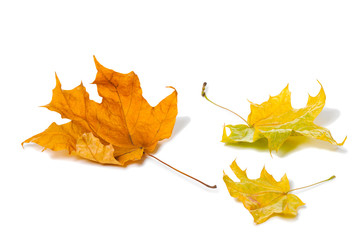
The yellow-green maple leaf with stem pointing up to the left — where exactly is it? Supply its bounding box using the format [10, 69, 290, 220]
[202, 83, 347, 152]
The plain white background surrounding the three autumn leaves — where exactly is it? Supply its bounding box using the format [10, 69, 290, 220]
[0, 0, 361, 240]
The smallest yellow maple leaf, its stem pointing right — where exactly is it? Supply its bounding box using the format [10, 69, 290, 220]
[223, 161, 335, 224]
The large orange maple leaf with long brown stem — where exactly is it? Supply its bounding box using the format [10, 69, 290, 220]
[22, 57, 215, 187]
